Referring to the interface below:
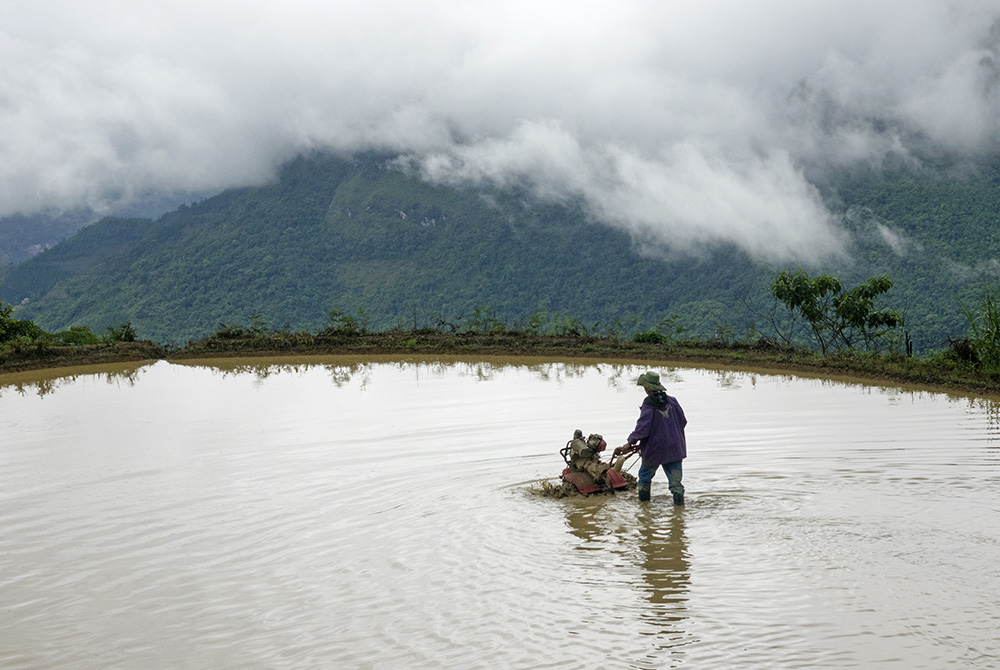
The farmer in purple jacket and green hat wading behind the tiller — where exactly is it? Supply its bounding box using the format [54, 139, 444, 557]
[614, 372, 687, 505]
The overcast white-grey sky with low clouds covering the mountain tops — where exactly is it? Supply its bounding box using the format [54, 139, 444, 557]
[0, 0, 1000, 261]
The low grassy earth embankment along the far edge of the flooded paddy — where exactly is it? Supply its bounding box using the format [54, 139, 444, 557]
[0, 329, 1000, 396]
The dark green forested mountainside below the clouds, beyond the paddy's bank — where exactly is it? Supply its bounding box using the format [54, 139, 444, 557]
[0, 154, 1000, 348]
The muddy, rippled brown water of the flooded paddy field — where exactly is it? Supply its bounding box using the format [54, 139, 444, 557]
[0, 359, 1000, 669]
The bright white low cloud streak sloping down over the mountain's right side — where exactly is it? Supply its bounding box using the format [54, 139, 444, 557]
[419, 123, 844, 262]
